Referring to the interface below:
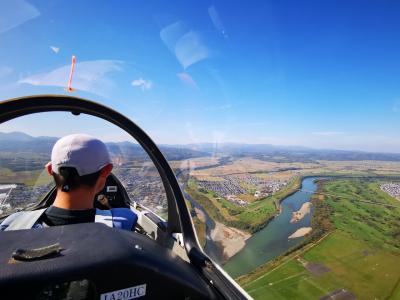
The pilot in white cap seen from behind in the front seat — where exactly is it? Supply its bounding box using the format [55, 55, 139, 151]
[0, 134, 137, 230]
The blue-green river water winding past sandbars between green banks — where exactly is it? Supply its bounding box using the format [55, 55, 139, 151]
[223, 177, 317, 278]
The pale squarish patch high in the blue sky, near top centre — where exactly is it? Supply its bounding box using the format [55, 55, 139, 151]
[160, 22, 210, 69]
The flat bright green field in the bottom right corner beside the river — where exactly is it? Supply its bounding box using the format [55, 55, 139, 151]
[244, 231, 400, 299]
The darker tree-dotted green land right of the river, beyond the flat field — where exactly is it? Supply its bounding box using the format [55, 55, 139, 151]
[323, 180, 400, 251]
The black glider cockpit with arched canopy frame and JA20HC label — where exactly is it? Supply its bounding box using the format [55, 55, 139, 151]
[0, 95, 249, 300]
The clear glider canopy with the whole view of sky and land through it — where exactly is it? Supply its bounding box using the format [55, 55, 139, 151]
[0, 0, 400, 299]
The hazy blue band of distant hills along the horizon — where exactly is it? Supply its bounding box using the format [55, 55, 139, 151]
[0, 132, 400, 169]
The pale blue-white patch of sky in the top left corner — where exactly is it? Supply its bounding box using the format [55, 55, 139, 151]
[0, 0, 40, 33]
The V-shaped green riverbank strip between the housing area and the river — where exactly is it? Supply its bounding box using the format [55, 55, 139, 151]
[186, 178, 301, 233]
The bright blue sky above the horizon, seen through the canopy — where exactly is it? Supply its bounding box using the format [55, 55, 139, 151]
[0, 0, 400, 152]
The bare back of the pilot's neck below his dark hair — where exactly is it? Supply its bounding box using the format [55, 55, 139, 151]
[53, 188, 96, 210]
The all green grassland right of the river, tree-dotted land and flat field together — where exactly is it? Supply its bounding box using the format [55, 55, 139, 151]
[239, 179, 400, 299]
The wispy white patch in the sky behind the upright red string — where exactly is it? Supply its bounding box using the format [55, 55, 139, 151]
[18, 60, 122, 96]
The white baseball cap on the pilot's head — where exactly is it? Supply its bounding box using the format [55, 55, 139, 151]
[51, 133, 111, 176]
